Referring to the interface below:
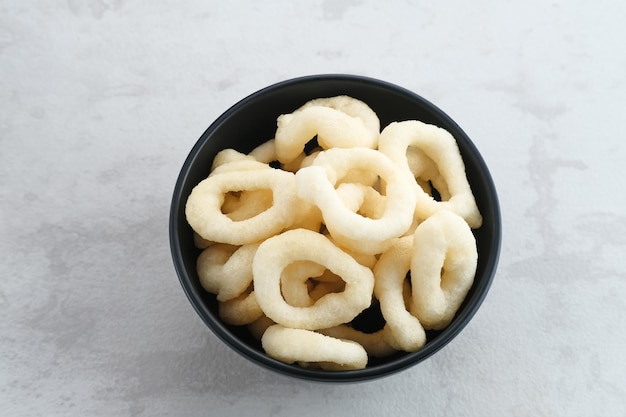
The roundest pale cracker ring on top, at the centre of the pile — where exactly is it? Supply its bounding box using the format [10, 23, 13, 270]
[296, 148, 416, 254]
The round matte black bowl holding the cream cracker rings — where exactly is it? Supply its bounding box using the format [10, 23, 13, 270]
[170, 75, 501, 382]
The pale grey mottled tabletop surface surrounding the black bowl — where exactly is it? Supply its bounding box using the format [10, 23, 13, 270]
[0, 0, 626, 417]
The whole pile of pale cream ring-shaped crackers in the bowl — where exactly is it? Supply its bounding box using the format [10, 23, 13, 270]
[186, 96, 482, 370]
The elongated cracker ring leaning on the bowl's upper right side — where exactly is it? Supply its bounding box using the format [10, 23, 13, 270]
[378, 120, 482, 228]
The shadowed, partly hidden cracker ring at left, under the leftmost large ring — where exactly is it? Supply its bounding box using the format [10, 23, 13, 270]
[196, 243, 259, 301]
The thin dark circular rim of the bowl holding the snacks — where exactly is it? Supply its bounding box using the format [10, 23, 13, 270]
[169, 73, 502, 382]
